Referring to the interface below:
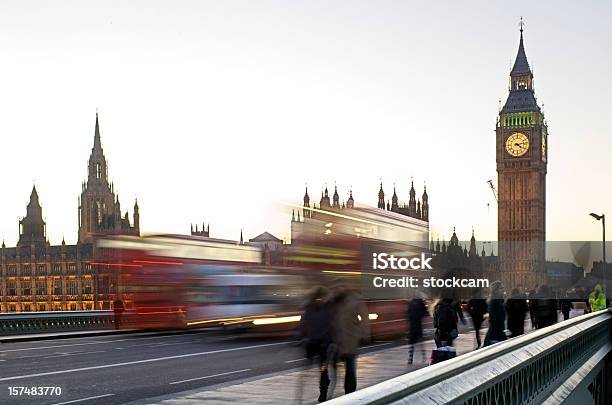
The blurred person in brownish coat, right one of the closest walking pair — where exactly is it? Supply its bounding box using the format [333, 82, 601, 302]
[329, 284, 370, 397]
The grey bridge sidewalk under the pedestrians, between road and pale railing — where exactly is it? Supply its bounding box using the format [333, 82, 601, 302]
[139, 330, 486, 405]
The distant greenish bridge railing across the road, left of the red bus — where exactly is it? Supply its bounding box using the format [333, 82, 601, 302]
[0, 311, 114, 336]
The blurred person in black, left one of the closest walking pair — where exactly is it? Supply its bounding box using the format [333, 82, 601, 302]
[300, 287, 332, 402]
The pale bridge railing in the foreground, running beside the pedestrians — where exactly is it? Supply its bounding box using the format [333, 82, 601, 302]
[328, 311, 612, 405]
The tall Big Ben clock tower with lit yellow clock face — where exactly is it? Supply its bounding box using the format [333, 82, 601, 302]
[496, 22, 548, 289]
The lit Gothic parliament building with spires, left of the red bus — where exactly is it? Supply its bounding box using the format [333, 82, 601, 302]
[0, 114, 140, 312]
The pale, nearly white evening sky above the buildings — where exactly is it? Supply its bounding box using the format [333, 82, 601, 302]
[0, 0, 612, 245]
